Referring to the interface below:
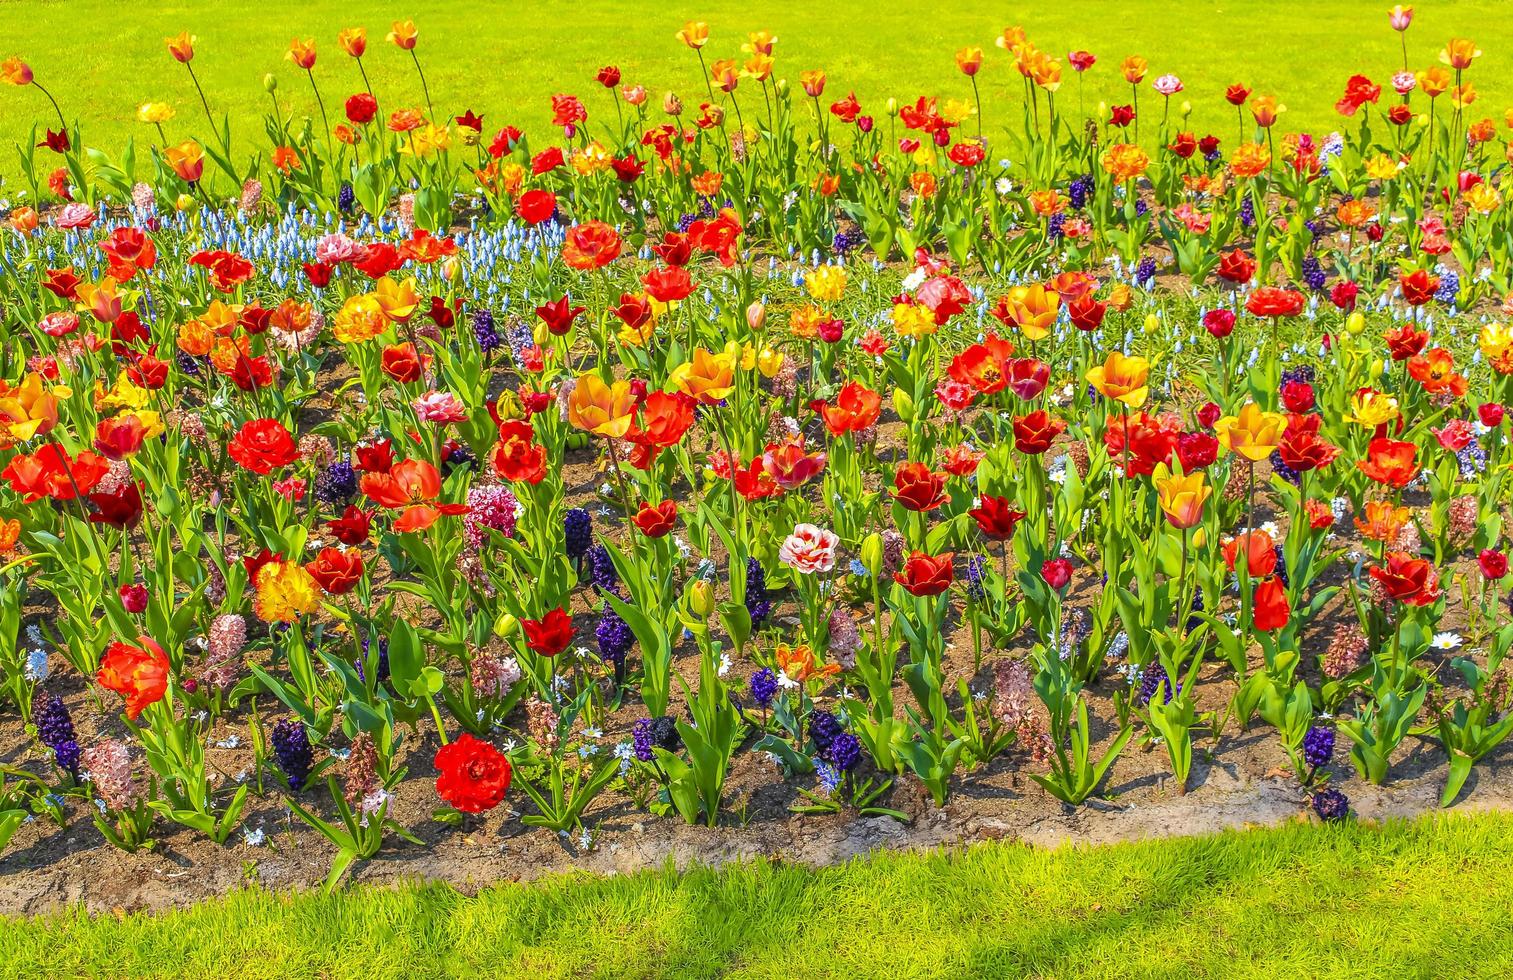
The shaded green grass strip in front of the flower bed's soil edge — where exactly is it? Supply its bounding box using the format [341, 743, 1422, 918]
[0, 815, 1513, 980]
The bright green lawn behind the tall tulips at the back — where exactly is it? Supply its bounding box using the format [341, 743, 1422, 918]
[0, 0, 1513, 183]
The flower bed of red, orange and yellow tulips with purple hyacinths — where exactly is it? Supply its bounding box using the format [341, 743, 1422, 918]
[0, 12, 1513, 907]
